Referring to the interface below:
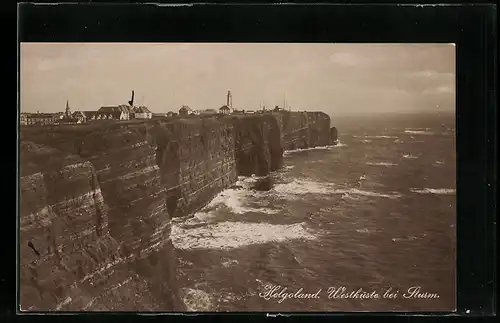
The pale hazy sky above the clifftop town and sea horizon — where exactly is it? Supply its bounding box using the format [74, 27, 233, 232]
[19, 43, 455, 116]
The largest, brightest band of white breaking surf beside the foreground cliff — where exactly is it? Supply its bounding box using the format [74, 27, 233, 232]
[171, 222, 316, 250]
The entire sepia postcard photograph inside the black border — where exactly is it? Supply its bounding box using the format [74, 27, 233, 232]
[18, 42, 457, 313]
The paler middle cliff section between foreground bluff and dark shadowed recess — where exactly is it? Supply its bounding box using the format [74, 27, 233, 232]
[160, 118, 237, 216]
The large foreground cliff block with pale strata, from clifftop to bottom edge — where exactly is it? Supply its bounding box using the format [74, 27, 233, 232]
[20, 129, 183, 311]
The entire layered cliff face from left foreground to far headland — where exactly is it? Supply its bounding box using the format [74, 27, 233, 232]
[19, 112, 332, 311]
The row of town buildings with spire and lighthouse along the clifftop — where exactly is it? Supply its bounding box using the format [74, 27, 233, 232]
[20, 91, 291, 126]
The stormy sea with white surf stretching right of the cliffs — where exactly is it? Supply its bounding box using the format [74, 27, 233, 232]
[172, 112, 456, 313]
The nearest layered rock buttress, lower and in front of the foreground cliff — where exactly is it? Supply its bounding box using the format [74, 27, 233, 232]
[19, 142, 178, 311]
